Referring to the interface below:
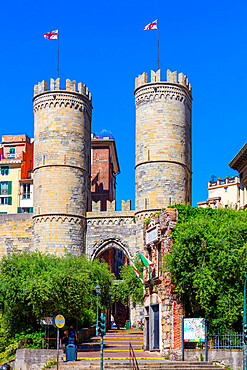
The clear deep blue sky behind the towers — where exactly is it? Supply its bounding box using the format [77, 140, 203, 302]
[0, 0, 247, 208]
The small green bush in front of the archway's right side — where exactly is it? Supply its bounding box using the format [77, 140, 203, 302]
[113, 257, 143, 307]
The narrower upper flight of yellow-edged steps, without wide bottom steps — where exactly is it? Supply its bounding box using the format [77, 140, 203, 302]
[74, 329, 162, 361]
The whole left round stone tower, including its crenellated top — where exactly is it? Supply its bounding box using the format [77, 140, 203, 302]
[33, 79, 92, 255]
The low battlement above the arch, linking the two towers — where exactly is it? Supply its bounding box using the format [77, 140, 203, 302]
[88, 200, 134, 216]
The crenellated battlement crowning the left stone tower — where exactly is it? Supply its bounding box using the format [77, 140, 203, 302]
[34, 78, 92, 101]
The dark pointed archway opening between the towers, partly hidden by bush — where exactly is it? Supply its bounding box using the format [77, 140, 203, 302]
[92, 240, 130, 328]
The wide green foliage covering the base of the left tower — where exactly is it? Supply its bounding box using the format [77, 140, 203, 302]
[0, 252, 113, 351]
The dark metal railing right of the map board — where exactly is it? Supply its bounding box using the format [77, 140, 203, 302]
[208, 333, 243, 349]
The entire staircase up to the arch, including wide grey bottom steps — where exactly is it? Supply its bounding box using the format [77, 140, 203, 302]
[51, 329, 219, 370]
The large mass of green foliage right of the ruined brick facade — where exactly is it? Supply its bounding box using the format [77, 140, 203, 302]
[165, 204, 247, 332]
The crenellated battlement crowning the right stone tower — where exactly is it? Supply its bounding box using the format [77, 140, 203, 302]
[135, 69, 192, 93]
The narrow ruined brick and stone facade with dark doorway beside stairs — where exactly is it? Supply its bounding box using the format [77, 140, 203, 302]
[144, 208, 184, 360]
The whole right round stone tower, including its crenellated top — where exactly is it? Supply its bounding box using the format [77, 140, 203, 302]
[135, 70, 192, 247]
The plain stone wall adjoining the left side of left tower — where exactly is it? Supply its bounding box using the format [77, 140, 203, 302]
[0, 213, 33, 257]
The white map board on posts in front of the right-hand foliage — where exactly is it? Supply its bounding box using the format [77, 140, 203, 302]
[184, 318, 205, 342]
